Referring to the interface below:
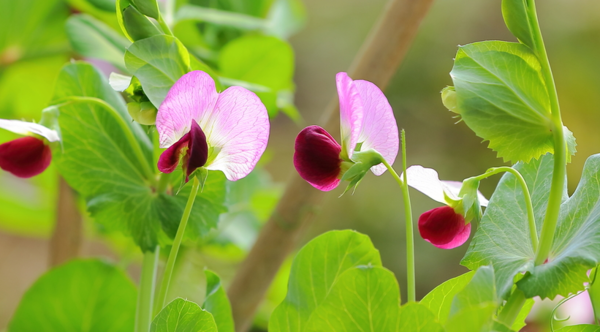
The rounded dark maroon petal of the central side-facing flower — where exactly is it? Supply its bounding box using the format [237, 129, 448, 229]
[294, 126, 342, 191]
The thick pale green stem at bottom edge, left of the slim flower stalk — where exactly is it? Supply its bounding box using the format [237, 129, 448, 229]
[135, 246, 160, 332]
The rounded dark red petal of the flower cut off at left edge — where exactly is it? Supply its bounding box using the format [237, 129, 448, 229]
[0, 136, 52, 178]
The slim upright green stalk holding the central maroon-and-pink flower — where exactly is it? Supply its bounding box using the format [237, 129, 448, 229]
[383, 129, 416, 302]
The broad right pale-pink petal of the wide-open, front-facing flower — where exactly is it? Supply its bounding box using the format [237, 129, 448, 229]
[199, 86, 270, 181]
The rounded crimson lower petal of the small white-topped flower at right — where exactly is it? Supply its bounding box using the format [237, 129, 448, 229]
[419, 206, 471, 249]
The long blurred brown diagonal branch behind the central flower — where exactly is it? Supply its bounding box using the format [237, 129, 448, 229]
[228, 0, 433, 332]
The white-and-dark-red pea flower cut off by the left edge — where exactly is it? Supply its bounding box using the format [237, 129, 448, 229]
[0, 119, 60, 178]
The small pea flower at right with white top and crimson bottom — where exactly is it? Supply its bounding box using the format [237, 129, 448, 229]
[406, 165, 488, 249]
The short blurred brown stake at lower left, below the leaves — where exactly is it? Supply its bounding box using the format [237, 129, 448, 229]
[49, 177, 83, 267]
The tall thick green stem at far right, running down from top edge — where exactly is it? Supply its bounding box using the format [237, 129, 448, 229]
[527, 0, 567, 265]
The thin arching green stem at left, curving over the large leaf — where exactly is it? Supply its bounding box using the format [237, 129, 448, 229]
[54, 96, 156, 186]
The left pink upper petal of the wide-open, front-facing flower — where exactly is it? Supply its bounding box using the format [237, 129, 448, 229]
[156, 70, 219, 148]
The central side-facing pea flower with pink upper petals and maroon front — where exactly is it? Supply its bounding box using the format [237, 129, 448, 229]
[294, 73, 399, 191]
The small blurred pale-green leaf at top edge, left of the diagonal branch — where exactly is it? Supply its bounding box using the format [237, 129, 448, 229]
[263, 0, 306, 39]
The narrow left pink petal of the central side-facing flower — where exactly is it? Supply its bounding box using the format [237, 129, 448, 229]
[335, 73, 363, 158]
